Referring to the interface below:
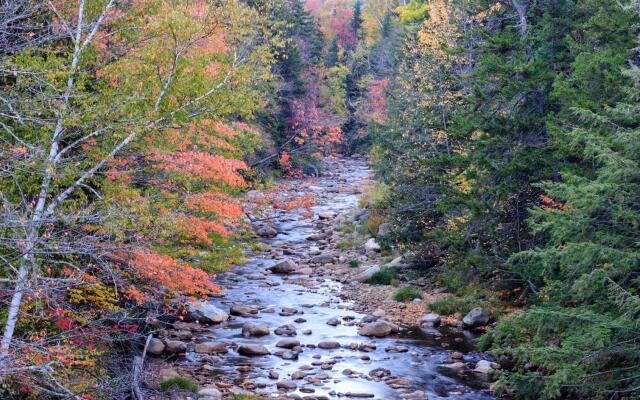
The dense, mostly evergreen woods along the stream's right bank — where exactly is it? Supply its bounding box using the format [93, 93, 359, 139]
[370, 0, 640, 399]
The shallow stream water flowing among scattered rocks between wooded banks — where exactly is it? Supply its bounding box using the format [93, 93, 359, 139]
[178, 158, 491, 399]
